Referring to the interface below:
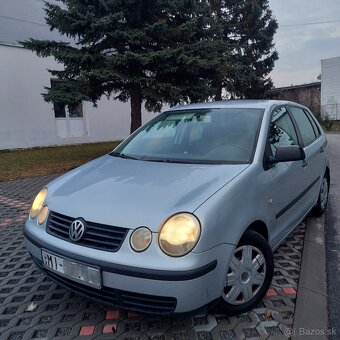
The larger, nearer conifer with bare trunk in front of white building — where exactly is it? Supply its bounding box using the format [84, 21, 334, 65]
[22, 0, 223, 132]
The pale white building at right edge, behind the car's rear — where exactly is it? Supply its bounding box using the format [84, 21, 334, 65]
[321, 57, 340, 120]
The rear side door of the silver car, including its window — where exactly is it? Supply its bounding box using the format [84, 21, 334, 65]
[288, 106, 326, 208]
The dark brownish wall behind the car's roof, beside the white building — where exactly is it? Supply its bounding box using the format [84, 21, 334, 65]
[266, 83, 321, 115]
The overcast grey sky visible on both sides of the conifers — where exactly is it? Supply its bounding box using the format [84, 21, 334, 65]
[0, 0, 340, 87]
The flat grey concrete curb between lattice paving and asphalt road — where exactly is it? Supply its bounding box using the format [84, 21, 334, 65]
[292, 215, 329, 340]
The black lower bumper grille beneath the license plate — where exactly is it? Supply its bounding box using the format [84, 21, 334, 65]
[32, 257, 177, 315]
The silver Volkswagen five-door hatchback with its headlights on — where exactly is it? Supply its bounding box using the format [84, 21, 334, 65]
[24, 101, 330, 314]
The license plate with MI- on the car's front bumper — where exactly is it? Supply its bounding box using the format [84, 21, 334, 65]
[41, 250, 102, 289]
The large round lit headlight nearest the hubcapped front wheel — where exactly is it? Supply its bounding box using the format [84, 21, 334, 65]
[159, 213, 201, 256]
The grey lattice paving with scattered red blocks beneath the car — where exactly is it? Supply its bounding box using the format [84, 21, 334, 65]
[0, 176, 305, 340]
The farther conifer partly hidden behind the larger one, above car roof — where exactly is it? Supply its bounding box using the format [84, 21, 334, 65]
[211, 0, 278, 99]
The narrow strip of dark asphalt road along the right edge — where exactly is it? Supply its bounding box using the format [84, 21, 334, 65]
[326, 133, 340, 339]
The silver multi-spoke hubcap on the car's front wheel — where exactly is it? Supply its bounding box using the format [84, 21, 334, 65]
[222, 245, 266, 305]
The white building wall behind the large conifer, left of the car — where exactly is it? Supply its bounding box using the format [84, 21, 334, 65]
[0, 45, 155, 149]
